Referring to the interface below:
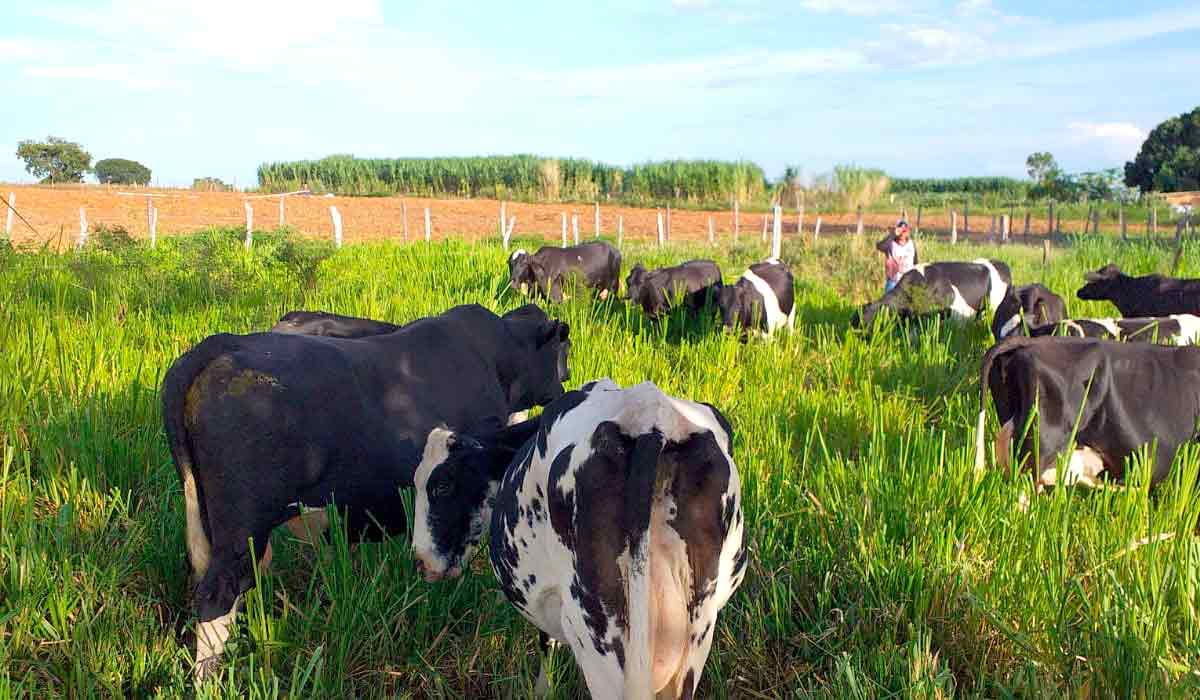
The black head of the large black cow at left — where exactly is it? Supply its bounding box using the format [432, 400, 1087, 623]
[504, 304, 571, 411]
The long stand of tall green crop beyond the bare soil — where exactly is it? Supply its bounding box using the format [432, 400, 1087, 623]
[258, 155, 766, 204]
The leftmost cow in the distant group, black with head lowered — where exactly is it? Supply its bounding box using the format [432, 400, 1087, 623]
[509, 240, 620, 301]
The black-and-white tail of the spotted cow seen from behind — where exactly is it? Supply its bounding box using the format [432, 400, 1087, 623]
[624, 429, 667, 700]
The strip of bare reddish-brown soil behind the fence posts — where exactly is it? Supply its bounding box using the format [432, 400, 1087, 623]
[0, 185, 1141, 247]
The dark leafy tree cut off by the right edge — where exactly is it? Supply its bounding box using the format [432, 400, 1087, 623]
[1124, 107, 1200, 192]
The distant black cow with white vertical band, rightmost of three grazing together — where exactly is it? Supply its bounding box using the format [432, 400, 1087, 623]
[716, 258, 796, 339]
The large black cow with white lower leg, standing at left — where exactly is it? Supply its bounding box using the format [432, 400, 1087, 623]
[162, 304, 570, 677]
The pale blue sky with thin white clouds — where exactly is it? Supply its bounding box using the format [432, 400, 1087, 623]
[0, 0, 1200, 186]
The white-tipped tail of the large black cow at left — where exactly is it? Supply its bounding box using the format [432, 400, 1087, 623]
[161, 334, 238, 582]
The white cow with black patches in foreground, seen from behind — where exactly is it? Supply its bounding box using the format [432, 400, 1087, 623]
[413, 379, 746, 698]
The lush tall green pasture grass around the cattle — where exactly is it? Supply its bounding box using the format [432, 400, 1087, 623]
[0, 231, 1200, 698]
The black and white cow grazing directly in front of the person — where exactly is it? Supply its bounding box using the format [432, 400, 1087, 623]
[851, 258, 1013, 328]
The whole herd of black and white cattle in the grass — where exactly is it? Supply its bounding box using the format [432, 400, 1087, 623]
[162, 243, 1200, 698]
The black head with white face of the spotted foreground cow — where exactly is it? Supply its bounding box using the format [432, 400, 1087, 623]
[413, 419, 539, 582]
